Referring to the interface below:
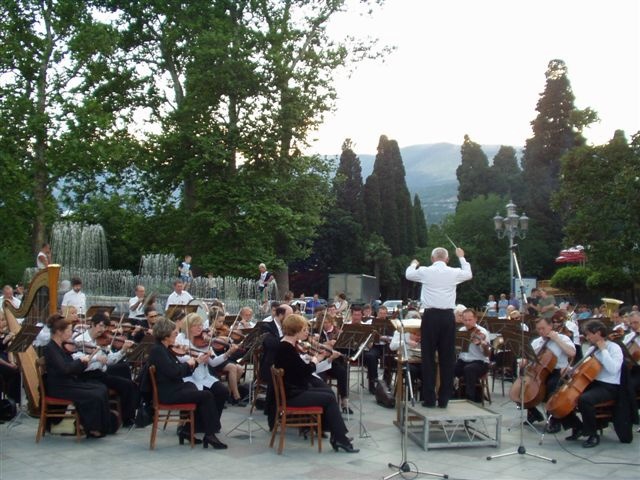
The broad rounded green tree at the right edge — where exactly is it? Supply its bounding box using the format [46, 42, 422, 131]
[553, 131, 640, 281]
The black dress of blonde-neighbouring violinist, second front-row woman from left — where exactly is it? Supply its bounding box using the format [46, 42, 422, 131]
[148, 342, 221, 435]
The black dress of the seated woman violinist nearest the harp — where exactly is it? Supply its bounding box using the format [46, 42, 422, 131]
[44, 340, 113, 434]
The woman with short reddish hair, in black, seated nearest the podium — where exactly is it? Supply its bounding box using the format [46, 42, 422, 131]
[274, 314, 359, 453]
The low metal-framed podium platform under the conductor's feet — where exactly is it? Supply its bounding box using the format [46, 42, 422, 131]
[396, 400, 502, 450]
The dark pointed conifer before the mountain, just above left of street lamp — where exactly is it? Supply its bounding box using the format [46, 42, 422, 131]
[456, 135, 491, 204]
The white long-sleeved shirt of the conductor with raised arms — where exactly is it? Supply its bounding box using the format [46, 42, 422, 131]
[405, 257, 473, 310]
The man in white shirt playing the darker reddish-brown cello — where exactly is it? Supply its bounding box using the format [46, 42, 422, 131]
[527, 316, 576, 433]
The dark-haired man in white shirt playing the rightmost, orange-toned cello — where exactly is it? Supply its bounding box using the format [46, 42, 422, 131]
[562, 320, 623, 448]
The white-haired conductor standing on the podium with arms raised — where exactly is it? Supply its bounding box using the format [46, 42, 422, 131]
[405, 247, 472, 408]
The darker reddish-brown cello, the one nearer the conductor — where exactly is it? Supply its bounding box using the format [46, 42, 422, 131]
[509, 337, 558, 408]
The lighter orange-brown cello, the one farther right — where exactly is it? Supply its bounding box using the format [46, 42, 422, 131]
[546, 346, 602, 418]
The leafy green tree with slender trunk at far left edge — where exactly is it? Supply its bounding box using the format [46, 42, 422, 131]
[0, 0, 139, 251]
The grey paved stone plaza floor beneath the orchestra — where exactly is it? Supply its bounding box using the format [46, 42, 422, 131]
[0, 383, 640, 480]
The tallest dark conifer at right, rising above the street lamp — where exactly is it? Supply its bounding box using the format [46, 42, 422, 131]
[522, 60, 595, 275]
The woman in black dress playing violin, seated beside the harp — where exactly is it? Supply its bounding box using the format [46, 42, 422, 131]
[44, 313, 115, 438]
